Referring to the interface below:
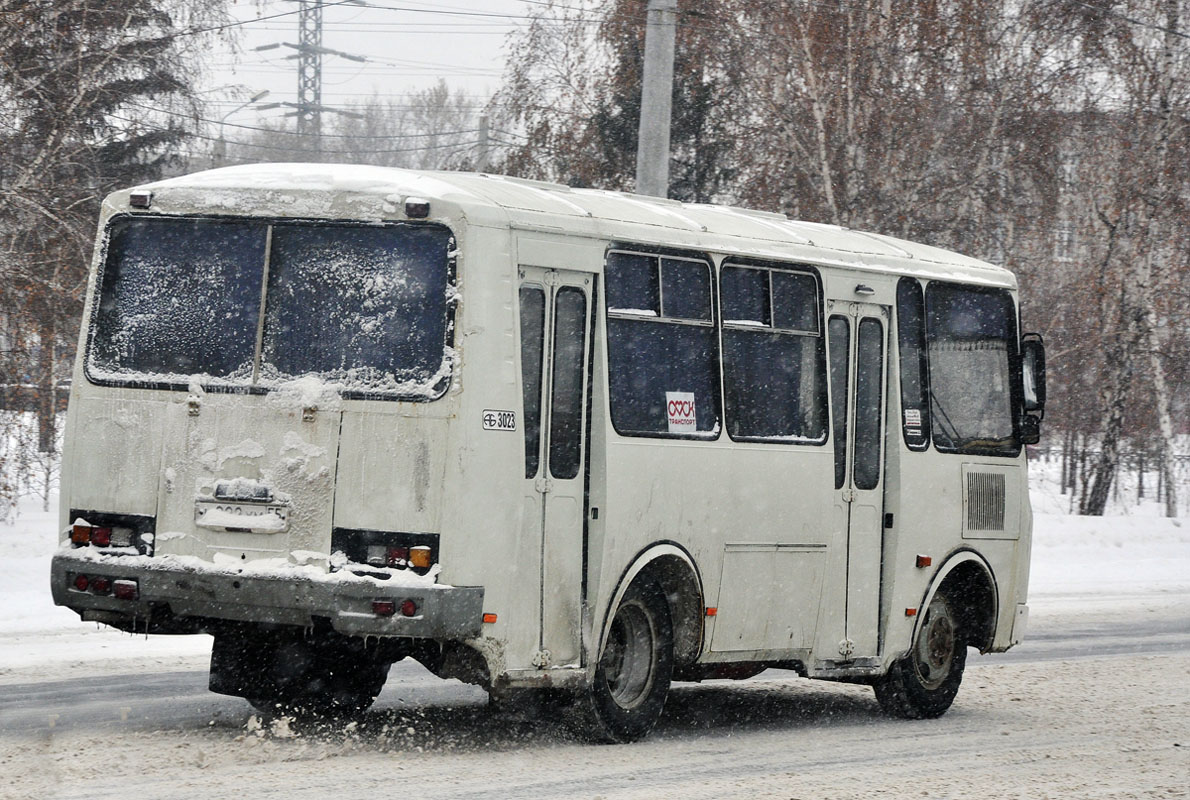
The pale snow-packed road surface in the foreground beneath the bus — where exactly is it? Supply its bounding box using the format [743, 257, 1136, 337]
[0, 651, 1190, 800]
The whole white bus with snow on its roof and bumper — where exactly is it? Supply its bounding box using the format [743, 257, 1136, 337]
[51, 164, 1044, 742]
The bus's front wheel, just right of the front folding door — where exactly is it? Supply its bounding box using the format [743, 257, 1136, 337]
[873, 589, 966, 719]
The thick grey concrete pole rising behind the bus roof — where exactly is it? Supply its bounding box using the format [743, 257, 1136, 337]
[637, 0, 677, 198]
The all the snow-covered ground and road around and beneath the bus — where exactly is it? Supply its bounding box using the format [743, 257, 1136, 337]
[0, 464, 1190, 800]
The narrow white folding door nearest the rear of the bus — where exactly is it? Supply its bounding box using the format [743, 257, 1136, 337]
[520, 267, 593, 668]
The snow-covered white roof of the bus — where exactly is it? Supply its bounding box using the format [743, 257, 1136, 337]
[120, 163, 1016, 287]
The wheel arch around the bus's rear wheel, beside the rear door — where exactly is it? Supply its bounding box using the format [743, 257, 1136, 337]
[593, 542, 703, 665]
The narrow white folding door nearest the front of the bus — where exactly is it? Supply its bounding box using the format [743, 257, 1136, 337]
[827, 301, 889, 661]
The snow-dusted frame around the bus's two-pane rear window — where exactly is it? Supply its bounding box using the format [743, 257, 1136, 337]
[82, 212, 461, 402]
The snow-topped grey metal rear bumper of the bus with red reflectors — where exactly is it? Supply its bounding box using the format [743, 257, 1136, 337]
[50, 549, 483, 640]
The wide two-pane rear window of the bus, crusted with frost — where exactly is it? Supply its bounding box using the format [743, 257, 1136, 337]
[87, 217, 453, 400]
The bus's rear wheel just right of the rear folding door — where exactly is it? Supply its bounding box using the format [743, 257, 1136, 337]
[572, 580, 674, 744]
